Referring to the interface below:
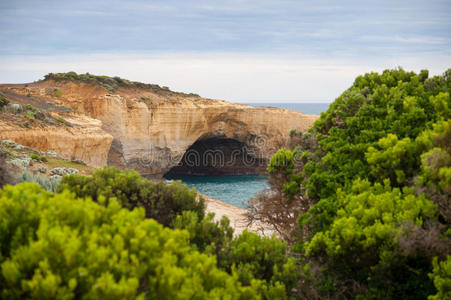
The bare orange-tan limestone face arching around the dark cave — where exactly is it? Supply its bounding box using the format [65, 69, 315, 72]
[35, 81, 317, 177]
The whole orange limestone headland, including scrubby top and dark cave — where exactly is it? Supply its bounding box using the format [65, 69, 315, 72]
[0, 72, 318, 177]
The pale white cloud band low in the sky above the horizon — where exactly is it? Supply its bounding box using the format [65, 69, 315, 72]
[0, 53, 451, 102]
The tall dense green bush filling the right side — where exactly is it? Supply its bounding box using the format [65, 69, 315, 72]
[253, 69, 451, 299]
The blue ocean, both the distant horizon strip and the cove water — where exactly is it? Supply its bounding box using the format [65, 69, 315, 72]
[167, 103, 329, 208]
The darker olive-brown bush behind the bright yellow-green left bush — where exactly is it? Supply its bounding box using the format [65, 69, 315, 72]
[58, 167, 205, 226]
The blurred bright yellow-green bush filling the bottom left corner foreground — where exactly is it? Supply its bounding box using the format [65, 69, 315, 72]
[0, 183, 257, 299]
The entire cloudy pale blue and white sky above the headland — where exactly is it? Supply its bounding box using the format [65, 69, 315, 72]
[0, 0, 451, 103]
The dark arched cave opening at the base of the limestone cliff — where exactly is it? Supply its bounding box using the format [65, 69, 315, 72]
[165, 137, 267, 178]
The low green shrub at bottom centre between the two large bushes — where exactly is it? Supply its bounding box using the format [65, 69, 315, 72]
[173, 211, 297, 299]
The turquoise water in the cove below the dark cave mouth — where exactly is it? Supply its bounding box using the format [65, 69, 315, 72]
[167, 175, 268, 208]
